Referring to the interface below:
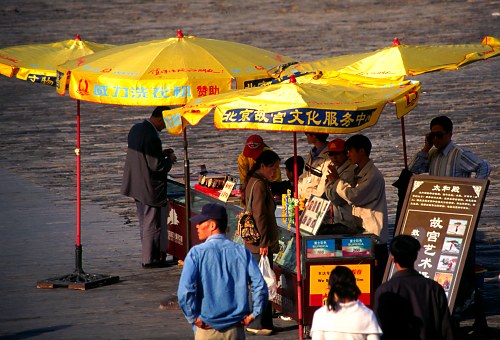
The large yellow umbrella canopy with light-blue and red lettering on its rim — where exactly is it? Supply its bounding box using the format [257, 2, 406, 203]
[57, 30, 295, 106]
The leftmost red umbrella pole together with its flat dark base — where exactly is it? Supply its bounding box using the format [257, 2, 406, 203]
[36, 100, 120, 290]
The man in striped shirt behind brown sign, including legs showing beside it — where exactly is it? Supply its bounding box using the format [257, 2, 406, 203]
[409, 116, 491, 333]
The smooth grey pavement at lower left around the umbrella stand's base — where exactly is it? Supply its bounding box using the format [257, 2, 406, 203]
[0, 162, 298, 340]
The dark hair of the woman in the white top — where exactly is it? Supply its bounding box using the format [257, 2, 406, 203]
[326, 266, 361, 310]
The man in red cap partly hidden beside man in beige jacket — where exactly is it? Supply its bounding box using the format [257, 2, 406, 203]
[325, 138, 356, 232]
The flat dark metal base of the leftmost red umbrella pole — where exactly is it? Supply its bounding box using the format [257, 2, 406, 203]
[36, 245, 120, 290]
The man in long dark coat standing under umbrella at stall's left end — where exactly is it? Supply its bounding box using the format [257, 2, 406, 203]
[121, 106, 177, 268]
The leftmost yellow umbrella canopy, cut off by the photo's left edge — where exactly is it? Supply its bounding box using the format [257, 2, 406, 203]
[0, 35, 115, 86]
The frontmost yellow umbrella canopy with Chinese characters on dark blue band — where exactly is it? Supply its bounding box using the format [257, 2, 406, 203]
[164, 73, 420, 134]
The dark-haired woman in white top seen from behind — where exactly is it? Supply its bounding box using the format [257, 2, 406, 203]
[311, 266, 382, 340]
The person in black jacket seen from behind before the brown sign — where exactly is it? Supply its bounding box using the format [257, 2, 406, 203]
[374, 235, 454, 340]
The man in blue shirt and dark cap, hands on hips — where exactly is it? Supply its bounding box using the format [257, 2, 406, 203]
[177, 204, 268, 339]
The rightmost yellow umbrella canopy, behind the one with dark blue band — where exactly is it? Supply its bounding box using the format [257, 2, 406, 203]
[285, 37, 500, 79]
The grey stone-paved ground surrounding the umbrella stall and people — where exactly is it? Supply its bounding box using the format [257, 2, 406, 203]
[0, 0, 500, 339]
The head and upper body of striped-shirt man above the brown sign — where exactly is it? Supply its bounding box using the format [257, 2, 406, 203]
[410, 116, 491, 179]
